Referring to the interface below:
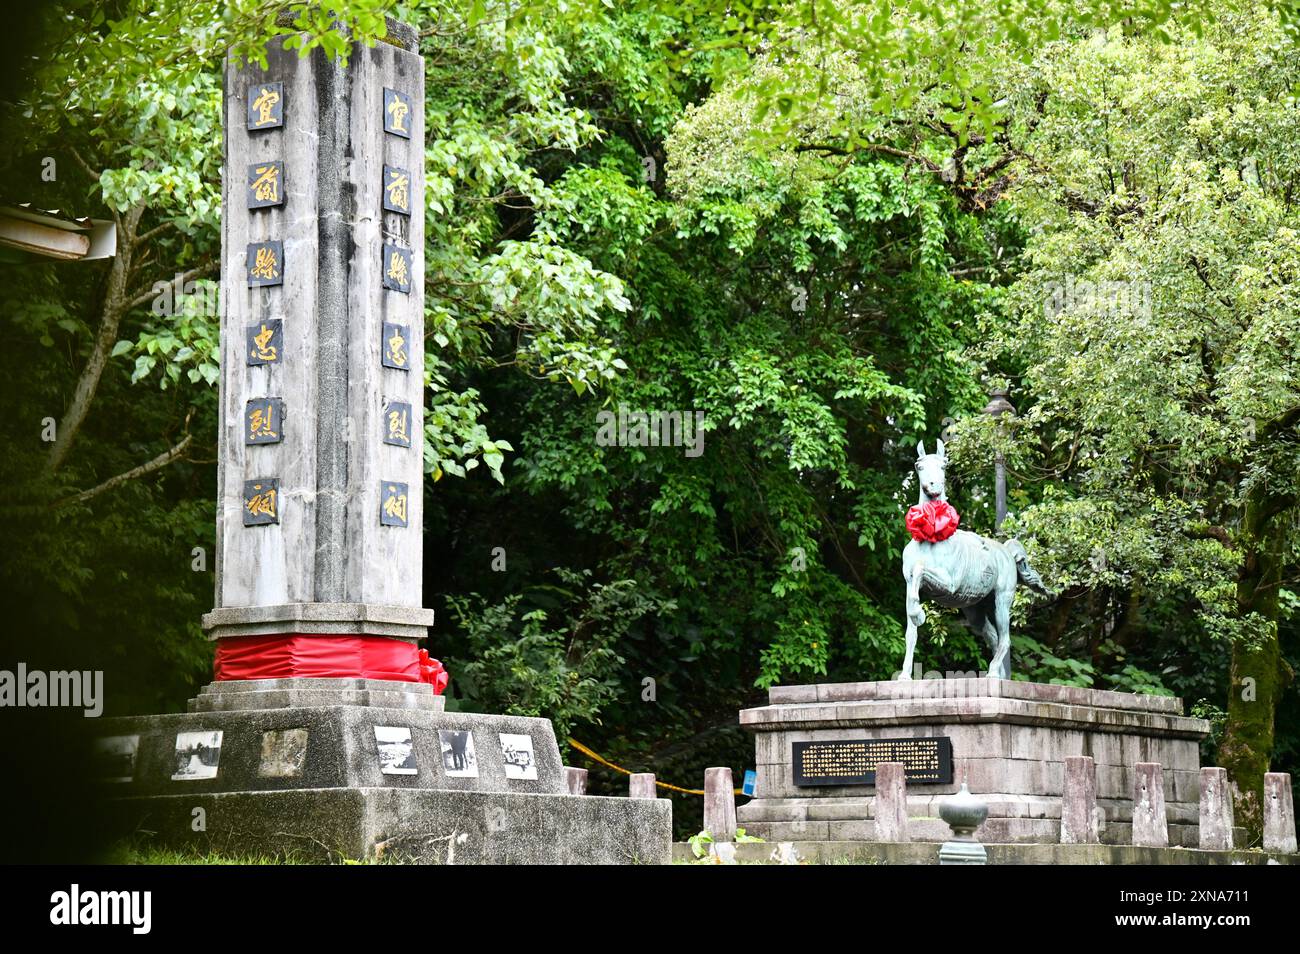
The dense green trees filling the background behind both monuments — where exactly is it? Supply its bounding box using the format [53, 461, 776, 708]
[0, 0, 1300, 847]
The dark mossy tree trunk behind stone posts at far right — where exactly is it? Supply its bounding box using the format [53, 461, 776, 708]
[1218, 489, 1292, 844]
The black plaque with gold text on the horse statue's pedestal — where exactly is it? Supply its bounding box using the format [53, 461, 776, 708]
[790, 736, 953, 785]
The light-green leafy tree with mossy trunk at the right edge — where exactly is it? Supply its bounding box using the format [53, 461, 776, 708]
[982, 4, 1300, 832]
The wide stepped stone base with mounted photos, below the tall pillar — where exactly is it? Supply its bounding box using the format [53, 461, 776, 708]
[94, 678, 672, 864]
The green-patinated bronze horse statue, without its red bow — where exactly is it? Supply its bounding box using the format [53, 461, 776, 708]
[900, 441, 1048, 680]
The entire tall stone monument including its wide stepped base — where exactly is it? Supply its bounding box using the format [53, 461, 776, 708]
[92, 21, 672, 864]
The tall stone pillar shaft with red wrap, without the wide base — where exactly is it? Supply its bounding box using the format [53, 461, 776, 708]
[203, 22, 433, 682]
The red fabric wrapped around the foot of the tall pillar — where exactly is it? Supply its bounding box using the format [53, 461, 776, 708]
[212, 633, 449, 695]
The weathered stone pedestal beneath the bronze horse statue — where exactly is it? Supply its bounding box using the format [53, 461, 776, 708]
[737, 678, 1209, 846]
